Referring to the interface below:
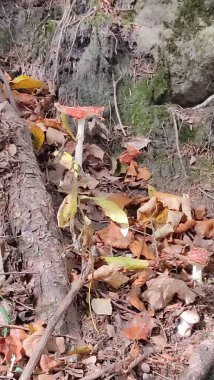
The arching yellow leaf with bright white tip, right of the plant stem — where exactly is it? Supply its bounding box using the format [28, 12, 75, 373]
[81, 195, 129, 236]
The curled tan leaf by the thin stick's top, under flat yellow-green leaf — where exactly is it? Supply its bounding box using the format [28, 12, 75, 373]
[88, 264, 129, 289]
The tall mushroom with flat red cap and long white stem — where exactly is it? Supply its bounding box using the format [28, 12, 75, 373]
[55, 103, 104, 167]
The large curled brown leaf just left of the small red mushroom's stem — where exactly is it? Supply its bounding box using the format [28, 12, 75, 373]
[142, 274, 196, 310]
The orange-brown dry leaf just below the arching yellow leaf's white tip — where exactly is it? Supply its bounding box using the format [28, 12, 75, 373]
[97, 222, 133, 249]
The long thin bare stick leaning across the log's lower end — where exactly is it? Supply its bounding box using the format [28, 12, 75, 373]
[20, 262, 91, 380]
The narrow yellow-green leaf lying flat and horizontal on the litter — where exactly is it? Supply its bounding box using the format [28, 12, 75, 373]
[103, 256, 149, 270]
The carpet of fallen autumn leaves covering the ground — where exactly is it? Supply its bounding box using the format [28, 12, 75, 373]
[0, 72, 214, 380]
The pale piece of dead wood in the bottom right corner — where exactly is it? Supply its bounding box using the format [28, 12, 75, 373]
[180, 339, 214, 380]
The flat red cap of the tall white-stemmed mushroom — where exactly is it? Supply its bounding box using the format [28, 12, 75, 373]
[54, 103, 104, 120]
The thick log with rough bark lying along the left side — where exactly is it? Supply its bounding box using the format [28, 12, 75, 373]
[0, 103, 79, 334]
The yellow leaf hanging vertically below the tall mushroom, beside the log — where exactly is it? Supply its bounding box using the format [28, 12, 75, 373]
[57, 181, 78, 228]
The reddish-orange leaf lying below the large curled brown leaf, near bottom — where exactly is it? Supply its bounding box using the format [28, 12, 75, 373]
[123, 315, 154, 340]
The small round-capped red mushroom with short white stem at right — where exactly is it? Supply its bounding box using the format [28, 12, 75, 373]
[187, 247, 210, 284]
